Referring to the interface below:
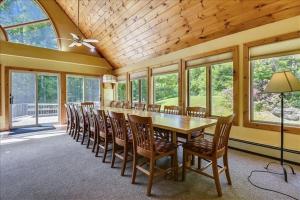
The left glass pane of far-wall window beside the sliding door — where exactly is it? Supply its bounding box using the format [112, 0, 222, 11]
[67, 77, 83, 103]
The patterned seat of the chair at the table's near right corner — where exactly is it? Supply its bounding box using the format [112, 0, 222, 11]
[182, 138, 213, 155]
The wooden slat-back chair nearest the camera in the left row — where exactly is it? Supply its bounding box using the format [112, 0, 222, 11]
[128, 115, 178, 196]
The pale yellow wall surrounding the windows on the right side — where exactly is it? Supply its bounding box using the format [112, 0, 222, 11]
[114, 15, 300, 159]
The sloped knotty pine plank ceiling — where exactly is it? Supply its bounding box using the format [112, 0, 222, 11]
[56, 0, 300, 68]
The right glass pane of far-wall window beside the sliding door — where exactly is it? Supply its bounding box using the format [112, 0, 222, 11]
[84, 77, 100, 106]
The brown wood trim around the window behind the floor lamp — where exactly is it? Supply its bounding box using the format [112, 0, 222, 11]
[243, 31, 300, 135]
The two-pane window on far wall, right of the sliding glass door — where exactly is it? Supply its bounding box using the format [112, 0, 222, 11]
[67, 76, 100, 106]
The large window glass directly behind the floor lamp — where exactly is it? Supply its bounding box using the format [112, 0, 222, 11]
[251, 54, 300, 126]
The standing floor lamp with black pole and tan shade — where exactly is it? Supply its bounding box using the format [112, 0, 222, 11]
[265, 71, 300, 182]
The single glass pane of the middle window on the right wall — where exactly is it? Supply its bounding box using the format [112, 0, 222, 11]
[154, 73, 178, 106]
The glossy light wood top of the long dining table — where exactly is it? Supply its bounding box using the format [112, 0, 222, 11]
[100, 107, 217, 134]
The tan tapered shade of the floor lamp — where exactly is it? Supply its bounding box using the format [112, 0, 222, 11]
[265, 71, 300, 93]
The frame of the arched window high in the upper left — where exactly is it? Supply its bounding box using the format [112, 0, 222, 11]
[0, 0, 61, 50]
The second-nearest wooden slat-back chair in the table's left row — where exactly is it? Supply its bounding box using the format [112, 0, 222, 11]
[109, 112, 132, 176]
